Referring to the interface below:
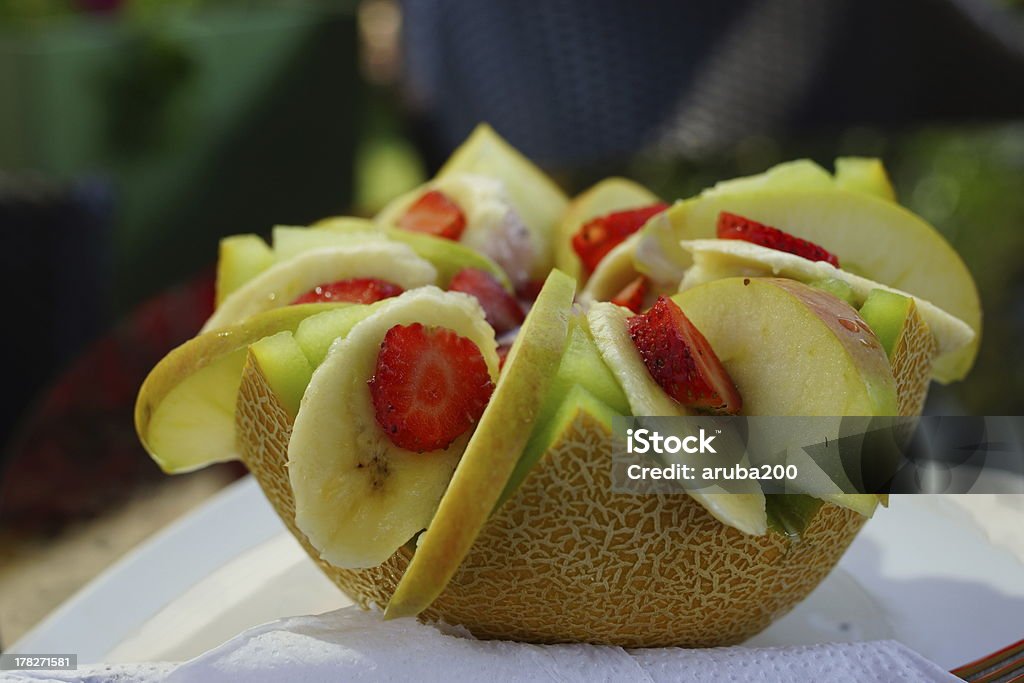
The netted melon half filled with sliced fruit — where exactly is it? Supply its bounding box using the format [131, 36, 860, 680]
[135, 126, 981, 647]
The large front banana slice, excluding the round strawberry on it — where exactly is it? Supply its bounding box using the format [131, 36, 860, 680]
[288, 287, 498, 568]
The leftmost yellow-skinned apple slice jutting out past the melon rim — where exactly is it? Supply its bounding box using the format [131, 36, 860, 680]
[135, 304, 346, 473]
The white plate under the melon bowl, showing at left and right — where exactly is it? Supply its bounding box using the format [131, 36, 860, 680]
[10, 477, 1024, 669]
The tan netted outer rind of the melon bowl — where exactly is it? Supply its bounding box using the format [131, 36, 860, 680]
[237, 357, 865, 647]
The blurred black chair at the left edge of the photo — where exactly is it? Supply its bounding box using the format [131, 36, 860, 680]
[0, 173, 113, 454]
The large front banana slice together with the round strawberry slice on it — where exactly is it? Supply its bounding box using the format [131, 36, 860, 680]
[288, 287, 498, 568]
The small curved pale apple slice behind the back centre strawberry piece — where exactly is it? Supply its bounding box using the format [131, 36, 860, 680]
[555, 178, 662, 282]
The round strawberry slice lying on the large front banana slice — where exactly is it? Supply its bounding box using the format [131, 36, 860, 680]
[368, 323, 495, 453]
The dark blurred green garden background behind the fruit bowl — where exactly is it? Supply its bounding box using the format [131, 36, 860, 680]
[0, 0, 1024, 643]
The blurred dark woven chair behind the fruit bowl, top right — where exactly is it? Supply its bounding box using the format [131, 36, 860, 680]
[402, 0, 1024, 169]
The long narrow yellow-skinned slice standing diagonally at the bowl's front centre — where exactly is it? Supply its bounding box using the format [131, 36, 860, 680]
[385, 270, 575, 618]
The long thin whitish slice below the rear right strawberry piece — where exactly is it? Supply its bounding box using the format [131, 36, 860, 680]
[681, 240, 976, 380]
